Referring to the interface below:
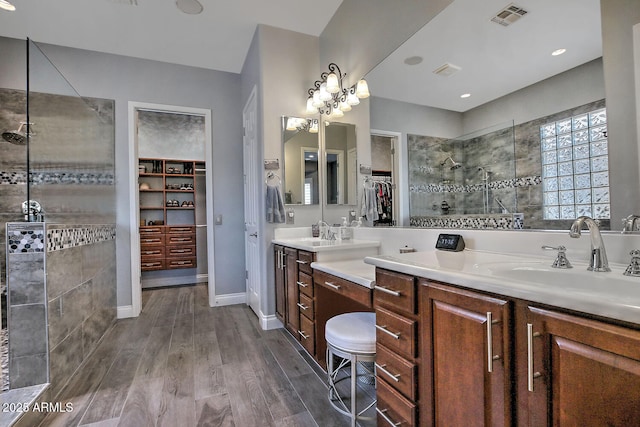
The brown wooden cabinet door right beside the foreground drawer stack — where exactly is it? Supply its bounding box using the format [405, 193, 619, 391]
[421, 282, 511, 426]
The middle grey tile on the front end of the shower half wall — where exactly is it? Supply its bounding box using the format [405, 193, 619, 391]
[9, 304, 47, 358]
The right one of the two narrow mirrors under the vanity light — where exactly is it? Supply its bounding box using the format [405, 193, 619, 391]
[324, 121, 358, 205]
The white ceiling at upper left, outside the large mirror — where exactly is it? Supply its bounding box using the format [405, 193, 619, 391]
[0, 0, 342, 73]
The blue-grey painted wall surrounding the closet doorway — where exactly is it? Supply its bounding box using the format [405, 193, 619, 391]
[0, 38, 245, 306]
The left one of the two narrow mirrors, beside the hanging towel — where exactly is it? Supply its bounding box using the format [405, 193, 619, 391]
[282, 116, 320, 205]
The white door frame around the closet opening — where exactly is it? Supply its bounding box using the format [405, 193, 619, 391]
[125, 101, 216, 318]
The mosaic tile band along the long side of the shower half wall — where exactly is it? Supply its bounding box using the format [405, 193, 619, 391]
[47, 224, 116, 252]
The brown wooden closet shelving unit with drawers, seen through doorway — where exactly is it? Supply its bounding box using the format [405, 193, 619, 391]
[138, 158, 196, 271]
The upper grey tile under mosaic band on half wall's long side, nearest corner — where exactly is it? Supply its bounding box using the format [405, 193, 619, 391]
[47, 247, 82, 300]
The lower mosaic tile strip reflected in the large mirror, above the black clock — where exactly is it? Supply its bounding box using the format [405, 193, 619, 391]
[409, 213, 524, 230]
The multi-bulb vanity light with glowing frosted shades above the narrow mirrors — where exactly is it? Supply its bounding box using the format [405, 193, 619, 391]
[306, 62, 370, 117]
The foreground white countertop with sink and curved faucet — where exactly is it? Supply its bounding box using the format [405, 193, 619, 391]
[364, 250, 640, 325]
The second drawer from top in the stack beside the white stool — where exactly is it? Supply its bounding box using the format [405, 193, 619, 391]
[376, 307, 418, 359]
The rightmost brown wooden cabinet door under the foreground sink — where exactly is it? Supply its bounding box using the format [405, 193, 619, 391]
[517, 307, 640, 427]
